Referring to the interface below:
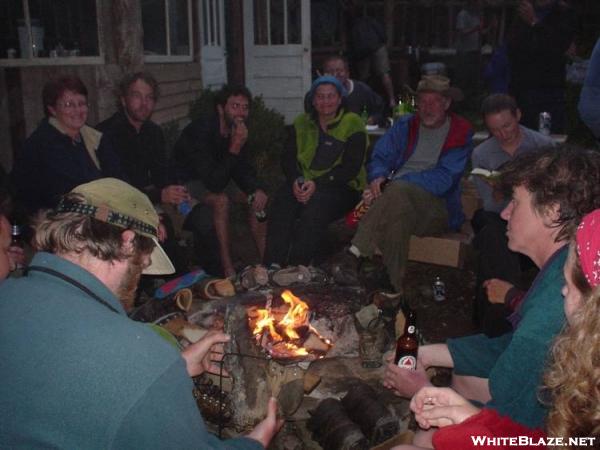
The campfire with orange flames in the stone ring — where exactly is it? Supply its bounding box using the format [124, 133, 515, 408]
[248, 290, 333, 361]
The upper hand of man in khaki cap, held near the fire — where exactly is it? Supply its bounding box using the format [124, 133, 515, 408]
[181, 331, 230, 377]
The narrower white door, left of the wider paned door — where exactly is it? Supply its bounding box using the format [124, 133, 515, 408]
[203, 0, 227, 89]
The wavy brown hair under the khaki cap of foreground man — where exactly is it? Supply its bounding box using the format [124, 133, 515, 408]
[33, 194, 155, 261]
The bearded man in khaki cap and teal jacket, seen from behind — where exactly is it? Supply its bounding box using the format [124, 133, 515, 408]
[0, 178, 279, 449]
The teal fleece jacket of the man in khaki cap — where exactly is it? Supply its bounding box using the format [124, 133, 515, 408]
[0, 253, 262, 449]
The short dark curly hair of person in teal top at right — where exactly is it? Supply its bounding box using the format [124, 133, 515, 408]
[498, 145, 600, 242]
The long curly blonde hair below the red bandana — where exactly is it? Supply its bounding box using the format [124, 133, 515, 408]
[544, 245, 600, 448]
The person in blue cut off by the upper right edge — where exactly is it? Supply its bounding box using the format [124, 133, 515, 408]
[577, 39, 600, 140]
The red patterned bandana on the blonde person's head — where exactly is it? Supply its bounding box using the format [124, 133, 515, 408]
[575, 209, 600, 287]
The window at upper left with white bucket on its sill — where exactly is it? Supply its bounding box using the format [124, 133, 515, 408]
[0, 0, 101, 65]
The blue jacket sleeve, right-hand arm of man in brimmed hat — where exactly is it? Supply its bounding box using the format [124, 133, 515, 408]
[401, 141, 471, 197]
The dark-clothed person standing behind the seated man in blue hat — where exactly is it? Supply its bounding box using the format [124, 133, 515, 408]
[348, 0, 396, 108]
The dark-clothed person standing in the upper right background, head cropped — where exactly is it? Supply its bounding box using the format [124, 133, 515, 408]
[507, 0, 576, 133]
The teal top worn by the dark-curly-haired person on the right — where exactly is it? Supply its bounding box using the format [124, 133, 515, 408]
[447, 246, 568, 428]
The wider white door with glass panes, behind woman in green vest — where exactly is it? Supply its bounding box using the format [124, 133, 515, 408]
[244, 0, 311, 123]
